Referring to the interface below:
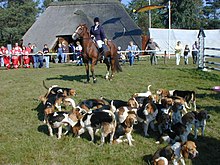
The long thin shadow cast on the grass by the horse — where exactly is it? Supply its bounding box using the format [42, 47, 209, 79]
[46, 75, 104, 83]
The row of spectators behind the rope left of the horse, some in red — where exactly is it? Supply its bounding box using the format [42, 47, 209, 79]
[0, 41, 83, 69]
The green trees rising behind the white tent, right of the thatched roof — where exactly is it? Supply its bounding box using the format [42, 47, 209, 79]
[124, 0, 220, 33]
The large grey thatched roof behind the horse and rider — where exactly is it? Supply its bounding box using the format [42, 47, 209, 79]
[23, 0, 141, 49]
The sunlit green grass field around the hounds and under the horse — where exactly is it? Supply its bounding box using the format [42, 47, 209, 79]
[0, 58, 220, 165]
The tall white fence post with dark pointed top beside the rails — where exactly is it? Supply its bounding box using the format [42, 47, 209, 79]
[198, 29, 206, 69]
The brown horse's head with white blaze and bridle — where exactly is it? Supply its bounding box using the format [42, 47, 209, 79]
[72, 24, 90, 40]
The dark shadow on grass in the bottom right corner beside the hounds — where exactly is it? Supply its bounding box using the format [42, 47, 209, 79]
[142, 134, 220, 165]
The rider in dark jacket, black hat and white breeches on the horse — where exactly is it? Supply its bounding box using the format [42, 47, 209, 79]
[90, 17, 107, 62]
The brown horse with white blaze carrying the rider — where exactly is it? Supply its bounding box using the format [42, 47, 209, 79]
[72, 24, 122, 83]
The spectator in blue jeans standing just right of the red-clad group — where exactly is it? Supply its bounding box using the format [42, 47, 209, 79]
[32, 44, 43, 68]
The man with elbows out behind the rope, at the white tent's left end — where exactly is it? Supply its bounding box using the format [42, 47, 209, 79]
[145, 38, 160, 65]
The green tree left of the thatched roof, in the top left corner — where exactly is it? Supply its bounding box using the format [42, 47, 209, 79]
[0, 0, 39, 45]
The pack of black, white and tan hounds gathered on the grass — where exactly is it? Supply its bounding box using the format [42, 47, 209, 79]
[40, 81, 209, 165]
